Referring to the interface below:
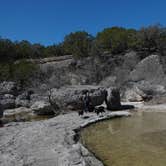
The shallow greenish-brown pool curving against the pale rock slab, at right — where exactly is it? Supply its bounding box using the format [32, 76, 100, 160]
[81, 112, 166, 166]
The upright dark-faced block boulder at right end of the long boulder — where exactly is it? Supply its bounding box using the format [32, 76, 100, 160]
[106, 88, 121, 110]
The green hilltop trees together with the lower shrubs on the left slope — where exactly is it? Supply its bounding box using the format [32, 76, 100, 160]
[0, 25, 166, 87]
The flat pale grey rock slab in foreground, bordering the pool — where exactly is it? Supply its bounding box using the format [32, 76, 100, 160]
[0, 111, 130, 166]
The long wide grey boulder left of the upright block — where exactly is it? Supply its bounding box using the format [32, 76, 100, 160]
[51, 85, 106, 110]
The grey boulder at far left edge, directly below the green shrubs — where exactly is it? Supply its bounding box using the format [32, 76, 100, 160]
[0, 81, 17, 95]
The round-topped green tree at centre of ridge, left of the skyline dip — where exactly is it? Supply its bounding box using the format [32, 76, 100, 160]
[63, 31, 93, 57]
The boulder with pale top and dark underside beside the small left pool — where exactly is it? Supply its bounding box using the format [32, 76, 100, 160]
[31, 101, 55, 115]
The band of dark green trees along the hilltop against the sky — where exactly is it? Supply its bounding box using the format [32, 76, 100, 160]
[0, 25, 166, 62]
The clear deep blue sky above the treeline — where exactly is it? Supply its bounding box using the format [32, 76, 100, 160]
[0, 0, 166, 45]
